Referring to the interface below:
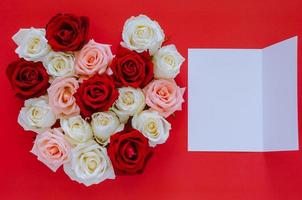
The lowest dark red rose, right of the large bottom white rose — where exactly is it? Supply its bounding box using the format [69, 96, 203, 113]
[108, 129, 152, 175]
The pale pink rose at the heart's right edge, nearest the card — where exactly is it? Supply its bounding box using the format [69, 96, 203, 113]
[144, 79, 185, 117]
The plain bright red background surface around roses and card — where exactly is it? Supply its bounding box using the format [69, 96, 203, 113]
[0, 0, 302, 200]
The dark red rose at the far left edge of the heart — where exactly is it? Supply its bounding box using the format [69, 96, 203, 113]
[6, 59, 49, 99]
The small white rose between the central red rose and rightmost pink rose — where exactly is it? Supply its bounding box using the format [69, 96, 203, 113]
[111, 87, 146, 123]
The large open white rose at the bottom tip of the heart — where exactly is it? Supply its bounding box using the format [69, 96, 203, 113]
[64, 140, 115, 186]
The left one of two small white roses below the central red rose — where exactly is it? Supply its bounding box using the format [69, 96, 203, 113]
[60, 115, 93, 145]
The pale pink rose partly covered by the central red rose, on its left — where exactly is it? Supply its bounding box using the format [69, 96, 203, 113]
[47, 77, 80, 117]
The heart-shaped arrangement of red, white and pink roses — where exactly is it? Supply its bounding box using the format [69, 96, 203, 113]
[6, 14, 184, 186]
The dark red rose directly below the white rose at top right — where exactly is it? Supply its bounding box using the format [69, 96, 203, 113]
[110, 47, 153, 88]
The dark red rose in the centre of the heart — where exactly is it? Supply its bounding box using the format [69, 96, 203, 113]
[75, 74, 119, 117]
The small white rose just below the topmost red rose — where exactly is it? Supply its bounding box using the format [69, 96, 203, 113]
[43, 51, 75, 77]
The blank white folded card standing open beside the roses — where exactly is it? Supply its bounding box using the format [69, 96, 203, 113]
[188, 37, 299, 152]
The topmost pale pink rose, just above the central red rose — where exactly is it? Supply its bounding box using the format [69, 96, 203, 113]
[75, 40, 113, 79]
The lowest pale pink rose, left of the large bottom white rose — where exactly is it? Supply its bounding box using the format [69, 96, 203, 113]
[31, 128, 71, 172]
